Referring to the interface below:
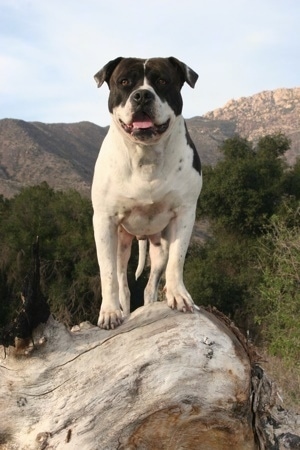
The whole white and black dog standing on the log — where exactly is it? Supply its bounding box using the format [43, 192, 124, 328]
[92, 57, 202, 329]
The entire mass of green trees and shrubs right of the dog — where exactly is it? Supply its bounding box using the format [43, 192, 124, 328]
[193, 133, 300, 370]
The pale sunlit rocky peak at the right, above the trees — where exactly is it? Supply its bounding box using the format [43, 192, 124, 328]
[204, 88, 300, 164]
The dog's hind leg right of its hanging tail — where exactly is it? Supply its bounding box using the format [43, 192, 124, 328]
[144, 233, 169, 305]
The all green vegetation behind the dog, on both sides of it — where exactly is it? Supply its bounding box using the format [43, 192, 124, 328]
[0, 133, 300, 404]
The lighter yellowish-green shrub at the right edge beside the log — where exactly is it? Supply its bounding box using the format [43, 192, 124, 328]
[253, 208, 300, 368]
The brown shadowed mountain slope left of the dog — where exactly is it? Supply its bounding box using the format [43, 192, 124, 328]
[0, 119, 107, 197]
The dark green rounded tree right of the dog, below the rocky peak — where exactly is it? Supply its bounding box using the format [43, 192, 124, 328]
[199, 133, 290, 235]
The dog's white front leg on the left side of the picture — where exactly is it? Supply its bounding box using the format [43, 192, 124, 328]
[93, 214, 122, 330]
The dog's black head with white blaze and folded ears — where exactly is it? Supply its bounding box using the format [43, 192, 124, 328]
[94, 57, 198, 144]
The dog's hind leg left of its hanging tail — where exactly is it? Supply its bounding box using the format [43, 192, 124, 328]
[117, 226, 133, 316]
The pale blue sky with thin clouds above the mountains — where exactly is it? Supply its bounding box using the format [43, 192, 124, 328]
[0, 0, 300, 126]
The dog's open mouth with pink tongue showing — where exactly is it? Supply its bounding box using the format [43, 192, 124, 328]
[120, 112, 170, 138]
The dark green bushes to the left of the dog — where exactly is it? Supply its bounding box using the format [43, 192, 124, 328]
[0, 183, 100, 324]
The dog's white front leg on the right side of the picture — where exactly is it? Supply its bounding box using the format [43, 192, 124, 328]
[165, 207, 195, 312]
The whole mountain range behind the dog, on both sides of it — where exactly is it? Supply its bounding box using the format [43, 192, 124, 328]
[0, 88, 300, 197]
